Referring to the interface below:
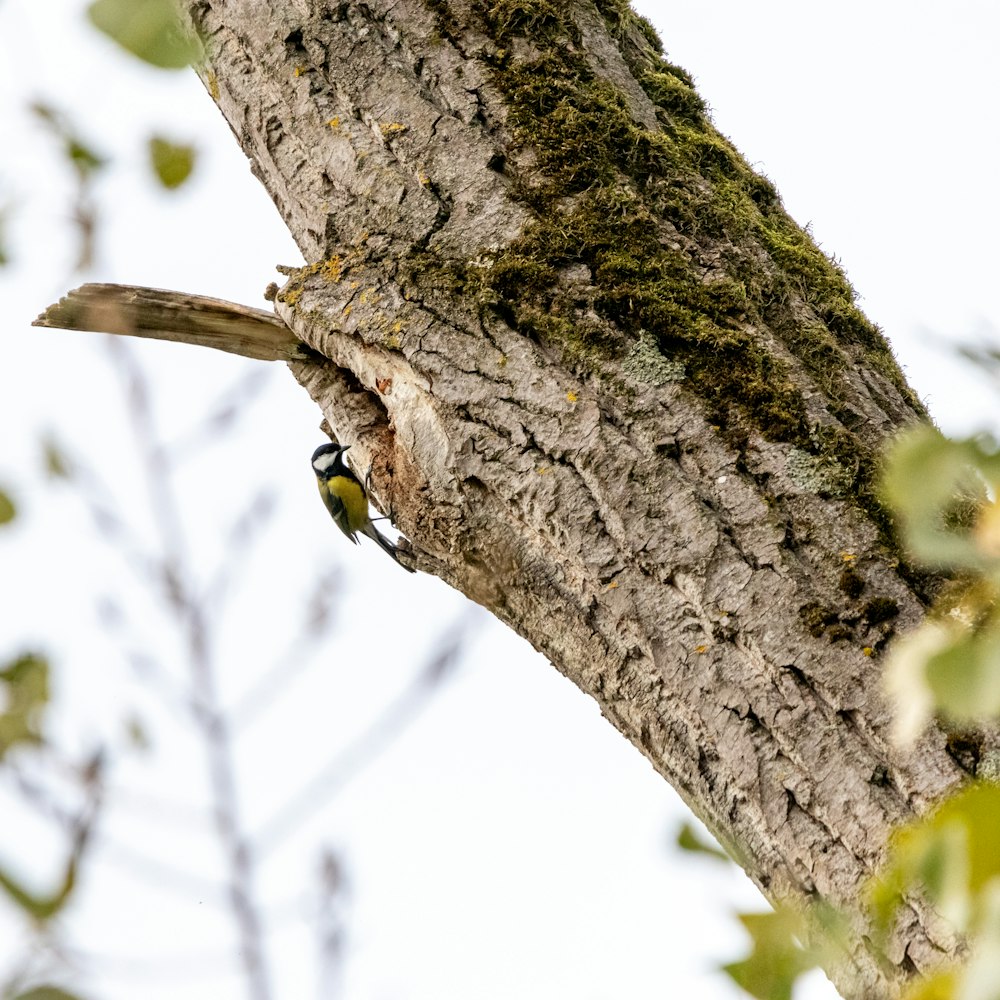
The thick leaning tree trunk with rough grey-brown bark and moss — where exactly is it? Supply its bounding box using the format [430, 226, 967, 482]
[174, 0, 964, 1000]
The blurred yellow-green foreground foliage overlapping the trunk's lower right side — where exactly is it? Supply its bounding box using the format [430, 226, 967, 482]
[724, 427, 1000, 1000]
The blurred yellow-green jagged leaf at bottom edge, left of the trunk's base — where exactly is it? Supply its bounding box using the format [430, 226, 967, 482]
[722, 909, 817, 1000]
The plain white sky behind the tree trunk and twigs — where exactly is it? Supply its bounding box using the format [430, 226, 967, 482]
[0, 0, 1000, 1000]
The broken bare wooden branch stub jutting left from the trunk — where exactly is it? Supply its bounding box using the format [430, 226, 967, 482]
[32, 284, 314, 361]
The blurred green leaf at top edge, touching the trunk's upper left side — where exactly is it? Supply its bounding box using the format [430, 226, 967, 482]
[87, 0, 203, 69]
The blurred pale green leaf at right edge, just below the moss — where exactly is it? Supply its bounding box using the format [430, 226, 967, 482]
[883, 427, 1000, 572]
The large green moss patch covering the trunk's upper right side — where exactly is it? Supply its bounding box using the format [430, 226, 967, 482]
[414, 0, 922, 534]
